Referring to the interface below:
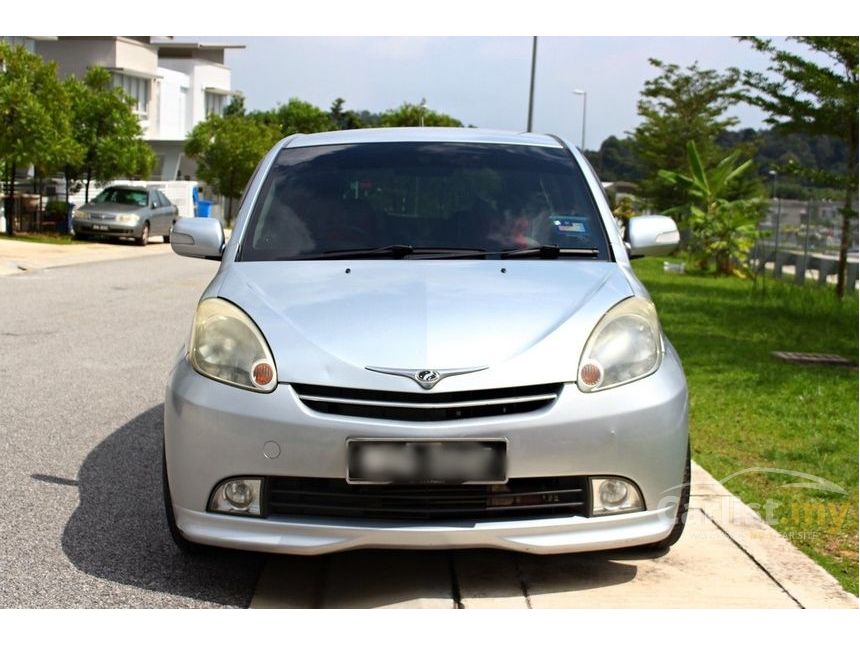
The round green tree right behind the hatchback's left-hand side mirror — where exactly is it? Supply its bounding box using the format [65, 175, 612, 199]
[185, 114, 281, 225]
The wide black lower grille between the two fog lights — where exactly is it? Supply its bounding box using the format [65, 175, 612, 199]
[263, 477, 588, 520]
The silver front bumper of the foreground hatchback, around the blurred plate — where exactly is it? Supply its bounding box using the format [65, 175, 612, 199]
[164, 346, 688, 555]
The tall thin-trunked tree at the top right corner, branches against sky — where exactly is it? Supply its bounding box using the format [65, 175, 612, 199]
[741, 36, 858, 298]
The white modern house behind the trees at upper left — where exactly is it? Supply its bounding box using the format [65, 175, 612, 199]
[33, 36, 244, 180]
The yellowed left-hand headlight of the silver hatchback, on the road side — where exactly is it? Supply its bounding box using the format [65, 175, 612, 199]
[189, 298, 278, 392]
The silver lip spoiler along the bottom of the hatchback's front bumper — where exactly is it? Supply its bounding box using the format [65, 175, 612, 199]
[174, 506, 675, 555]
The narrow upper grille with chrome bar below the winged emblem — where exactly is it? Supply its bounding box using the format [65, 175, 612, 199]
[293, 383, 562, 421]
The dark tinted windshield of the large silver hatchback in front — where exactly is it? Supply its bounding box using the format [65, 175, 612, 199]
[238, 142, 609, 261]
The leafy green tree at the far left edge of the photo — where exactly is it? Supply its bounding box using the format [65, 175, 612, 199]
[0, 42, 75, 235]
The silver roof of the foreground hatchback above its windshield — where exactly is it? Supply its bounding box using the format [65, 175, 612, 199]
[283, 127, 562, 148]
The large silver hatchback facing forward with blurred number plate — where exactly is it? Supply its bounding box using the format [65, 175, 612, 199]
[164, 128, 690, 554]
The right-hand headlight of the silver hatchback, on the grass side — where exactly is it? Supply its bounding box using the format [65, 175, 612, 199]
[576, 298, 663, 392]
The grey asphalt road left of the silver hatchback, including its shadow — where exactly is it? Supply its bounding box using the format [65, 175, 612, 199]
[0, 254, 262, 607]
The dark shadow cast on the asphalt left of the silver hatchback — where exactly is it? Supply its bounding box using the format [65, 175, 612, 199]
[63, 405, 263, 607]
